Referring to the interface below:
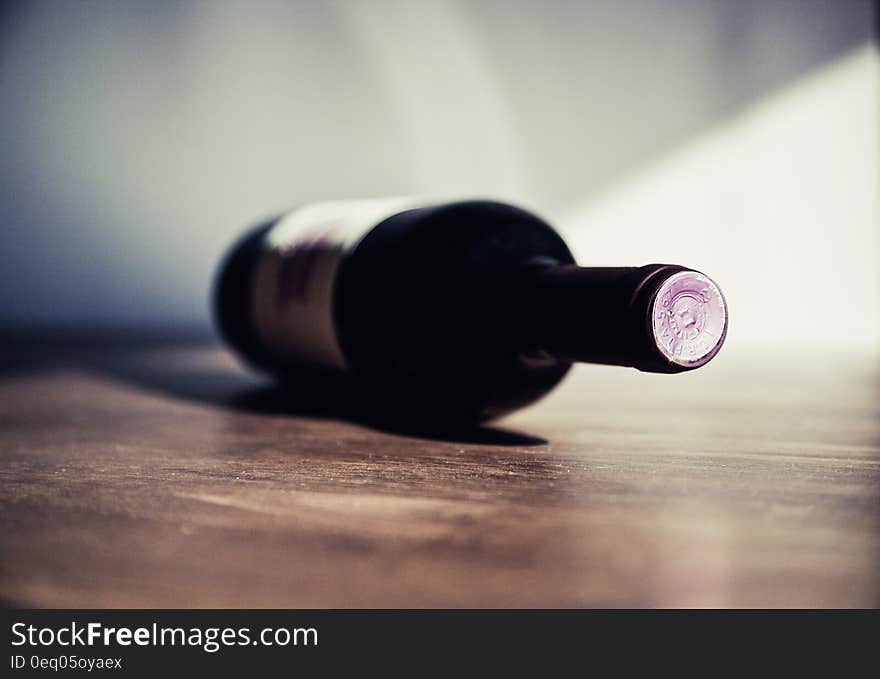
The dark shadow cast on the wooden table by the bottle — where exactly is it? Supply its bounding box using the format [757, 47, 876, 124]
[0, 331, 547, 446]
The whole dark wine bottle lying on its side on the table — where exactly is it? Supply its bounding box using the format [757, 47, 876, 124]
[215, 200, 727, 420]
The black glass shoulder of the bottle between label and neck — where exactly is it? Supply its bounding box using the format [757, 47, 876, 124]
[334, 201, 573, 416]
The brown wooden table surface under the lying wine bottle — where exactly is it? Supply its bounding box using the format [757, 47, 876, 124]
[0, 332, 880, 607]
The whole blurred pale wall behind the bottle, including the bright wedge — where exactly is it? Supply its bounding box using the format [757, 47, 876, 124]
[0, 0, 880, 349]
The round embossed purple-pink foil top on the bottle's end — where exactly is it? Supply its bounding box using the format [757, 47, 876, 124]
[651, 271, 727, 368]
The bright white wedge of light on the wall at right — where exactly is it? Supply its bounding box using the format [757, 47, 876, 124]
[560, 45, 880, 350]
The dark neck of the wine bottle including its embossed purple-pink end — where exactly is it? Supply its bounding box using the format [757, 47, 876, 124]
[519, 261, 726, 372]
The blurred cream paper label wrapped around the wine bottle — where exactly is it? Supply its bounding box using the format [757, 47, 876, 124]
[251, 198, 415, 370]
